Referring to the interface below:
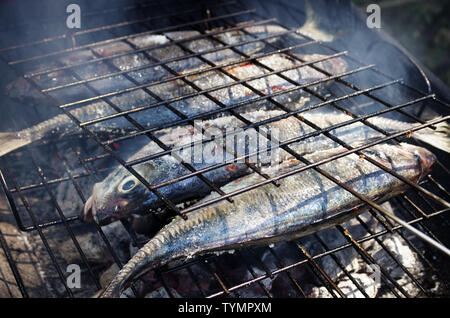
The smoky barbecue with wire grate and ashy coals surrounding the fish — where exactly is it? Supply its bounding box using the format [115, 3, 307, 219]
[0, 0, 450, 297]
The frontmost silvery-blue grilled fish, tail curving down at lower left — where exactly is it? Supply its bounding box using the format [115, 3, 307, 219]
[102, 144, 435, 297]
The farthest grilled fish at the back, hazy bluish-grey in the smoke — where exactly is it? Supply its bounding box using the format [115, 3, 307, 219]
[5, 25, 312, 104]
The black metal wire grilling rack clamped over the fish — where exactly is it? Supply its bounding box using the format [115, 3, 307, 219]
[0, 1, 450, 297]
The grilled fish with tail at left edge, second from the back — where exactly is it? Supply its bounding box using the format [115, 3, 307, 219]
[0, 47, 346, 156]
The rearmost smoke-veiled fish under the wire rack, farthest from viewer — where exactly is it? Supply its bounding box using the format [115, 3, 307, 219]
[5, 28, 282, 104]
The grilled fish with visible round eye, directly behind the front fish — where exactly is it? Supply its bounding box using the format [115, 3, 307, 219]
[83, 111, 450, 225]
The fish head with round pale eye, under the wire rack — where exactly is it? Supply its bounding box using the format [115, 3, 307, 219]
[82, 162, 157, 225]
